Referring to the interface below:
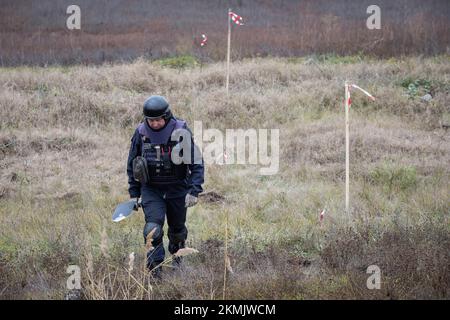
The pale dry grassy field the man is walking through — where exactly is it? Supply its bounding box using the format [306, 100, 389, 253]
[0, 55, 450, 299]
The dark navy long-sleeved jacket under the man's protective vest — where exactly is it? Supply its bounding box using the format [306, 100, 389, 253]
[127, 119, 205, 198]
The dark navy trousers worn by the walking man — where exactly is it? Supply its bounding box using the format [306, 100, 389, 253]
[141, 185, 188, 268]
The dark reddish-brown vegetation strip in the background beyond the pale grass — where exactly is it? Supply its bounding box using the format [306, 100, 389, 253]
[0, 0, 450, 66]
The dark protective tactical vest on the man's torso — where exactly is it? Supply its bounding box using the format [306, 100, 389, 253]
[133, 118, 188, 186]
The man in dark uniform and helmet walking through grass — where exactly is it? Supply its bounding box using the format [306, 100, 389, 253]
[127, 96, 204, 276]
